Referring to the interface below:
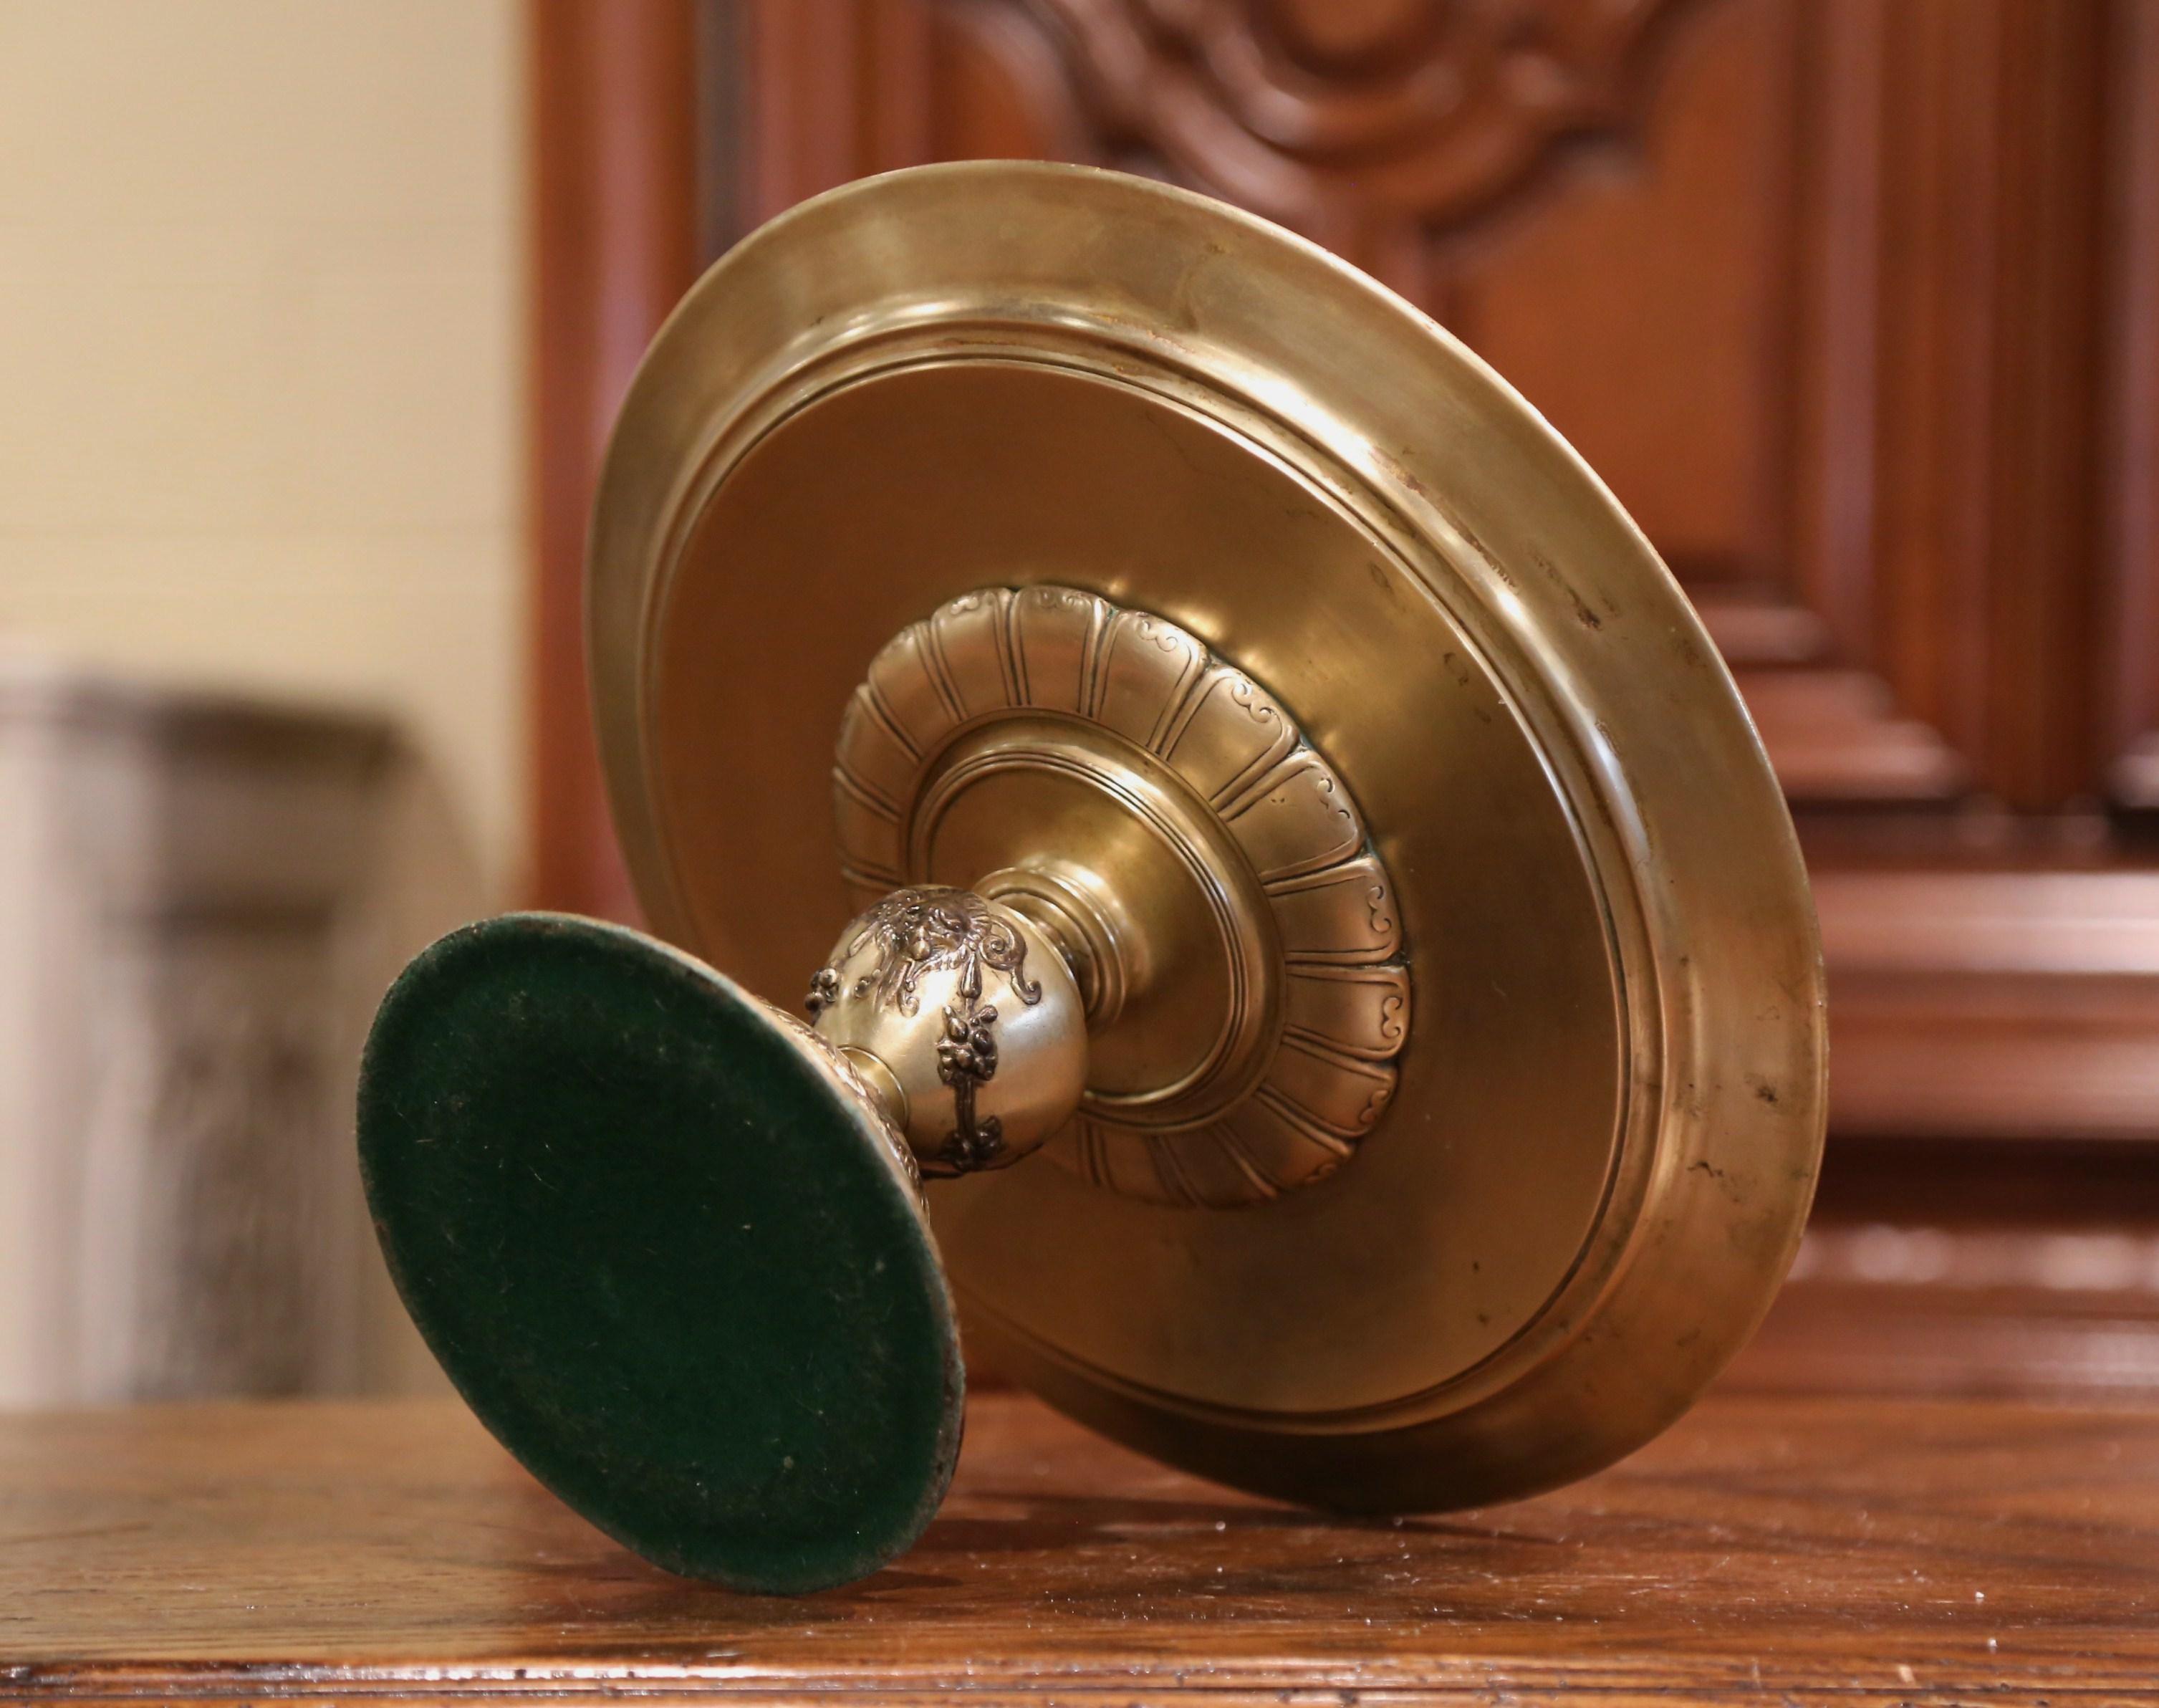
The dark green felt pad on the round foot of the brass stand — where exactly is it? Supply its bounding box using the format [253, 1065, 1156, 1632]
[358, 913, 963, 1593]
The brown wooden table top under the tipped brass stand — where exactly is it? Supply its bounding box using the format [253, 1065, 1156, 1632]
[0, 1393, 2159, 1708]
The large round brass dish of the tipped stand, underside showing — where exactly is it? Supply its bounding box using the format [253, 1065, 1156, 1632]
[592, 164, 1824, 1510]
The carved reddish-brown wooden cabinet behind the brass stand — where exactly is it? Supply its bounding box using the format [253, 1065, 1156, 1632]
[533, 0, 2159, 1391]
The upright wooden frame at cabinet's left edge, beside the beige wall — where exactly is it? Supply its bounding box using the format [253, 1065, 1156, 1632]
[524, 0, 928, 920]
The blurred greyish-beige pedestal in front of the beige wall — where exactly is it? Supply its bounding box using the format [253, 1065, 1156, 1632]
[0, 652, 455, 1406]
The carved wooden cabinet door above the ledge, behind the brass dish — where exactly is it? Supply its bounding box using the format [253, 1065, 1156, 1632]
[725, 0, 2124, 807]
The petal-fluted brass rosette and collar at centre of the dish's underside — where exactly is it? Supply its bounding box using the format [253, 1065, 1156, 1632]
[833, 587, 1410, 1209]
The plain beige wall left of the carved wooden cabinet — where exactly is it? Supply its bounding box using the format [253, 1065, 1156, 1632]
[0, 0, 524, 896]
